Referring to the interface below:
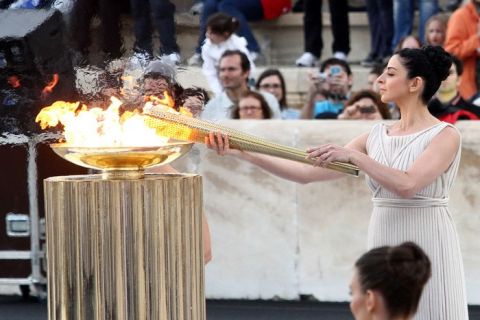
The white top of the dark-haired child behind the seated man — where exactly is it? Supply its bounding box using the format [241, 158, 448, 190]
[202, 33, 255, 97]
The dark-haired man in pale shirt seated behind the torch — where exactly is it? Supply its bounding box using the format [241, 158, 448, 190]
[201, 50, 281, 121]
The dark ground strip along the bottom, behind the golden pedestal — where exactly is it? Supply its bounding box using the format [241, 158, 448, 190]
[0, 295, 480, 320]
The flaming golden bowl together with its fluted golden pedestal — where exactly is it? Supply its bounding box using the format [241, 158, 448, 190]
[37, 95, 205, 320]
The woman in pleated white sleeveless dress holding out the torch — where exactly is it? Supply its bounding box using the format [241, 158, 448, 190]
[206, 47, 468, 320]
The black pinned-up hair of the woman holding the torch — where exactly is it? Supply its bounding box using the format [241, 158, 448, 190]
[396, 46, 452, 104]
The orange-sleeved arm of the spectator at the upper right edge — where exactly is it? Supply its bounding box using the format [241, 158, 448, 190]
[445, 14, 480, 59]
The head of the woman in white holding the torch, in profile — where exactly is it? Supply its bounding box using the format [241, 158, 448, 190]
[377, 46, 452, 108]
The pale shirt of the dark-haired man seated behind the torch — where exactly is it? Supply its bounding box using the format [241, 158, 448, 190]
[200, 91, 282, 121]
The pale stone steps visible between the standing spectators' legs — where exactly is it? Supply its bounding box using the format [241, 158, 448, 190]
[114, 0, 447, 107]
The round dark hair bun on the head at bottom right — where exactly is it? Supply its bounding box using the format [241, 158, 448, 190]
[386, 242, 431, 285]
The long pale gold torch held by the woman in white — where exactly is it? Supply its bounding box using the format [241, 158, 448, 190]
[144, 106, 360, 176]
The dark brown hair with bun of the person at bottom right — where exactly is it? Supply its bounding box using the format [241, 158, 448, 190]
[355, 242, 431, 318]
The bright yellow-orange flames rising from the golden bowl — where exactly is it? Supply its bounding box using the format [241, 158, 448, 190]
[35, 93, 191, 147]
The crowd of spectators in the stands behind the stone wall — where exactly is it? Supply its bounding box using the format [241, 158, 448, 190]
[2, 0, 480, 121]
